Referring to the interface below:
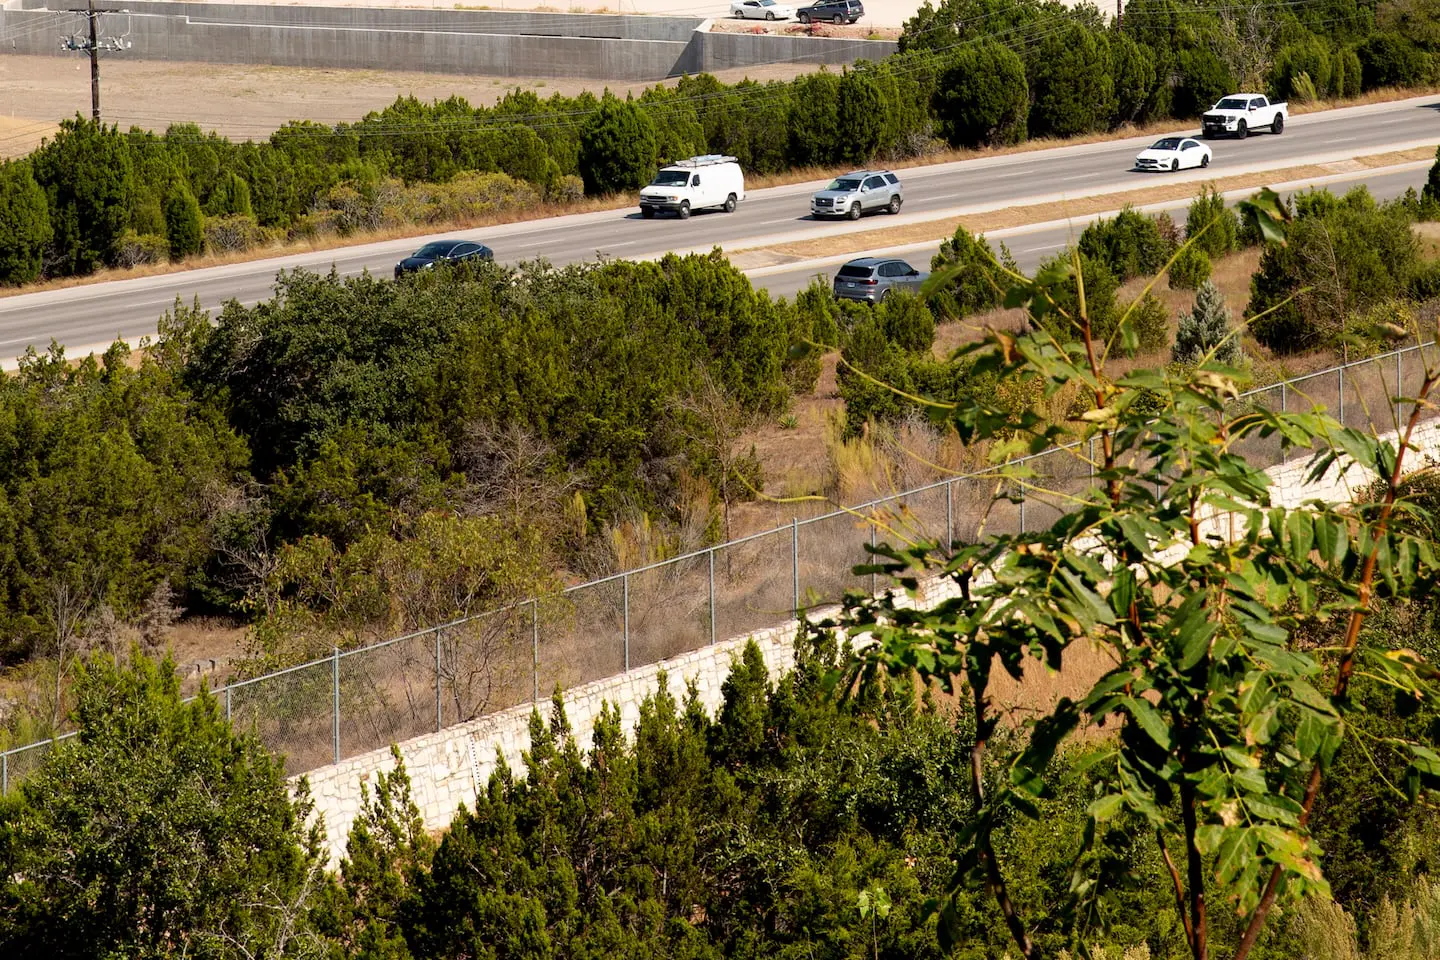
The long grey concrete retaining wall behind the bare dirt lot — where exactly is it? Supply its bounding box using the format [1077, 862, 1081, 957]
[0, 0, 896, 82]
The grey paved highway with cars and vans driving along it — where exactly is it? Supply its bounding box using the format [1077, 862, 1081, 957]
[0, 95, 1440, 366]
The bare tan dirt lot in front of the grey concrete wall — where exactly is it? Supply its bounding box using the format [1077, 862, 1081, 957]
[0, 56, 818, 157]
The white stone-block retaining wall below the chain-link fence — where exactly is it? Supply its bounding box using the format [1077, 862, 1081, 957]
[305, 420, 1440, 861]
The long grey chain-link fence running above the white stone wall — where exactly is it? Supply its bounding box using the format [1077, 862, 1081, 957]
[0, 347, 1424, 793]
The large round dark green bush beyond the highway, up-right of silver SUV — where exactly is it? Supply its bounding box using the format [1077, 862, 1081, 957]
[933, 40, 1030, 147]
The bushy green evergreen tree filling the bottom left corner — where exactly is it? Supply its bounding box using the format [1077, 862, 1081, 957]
[0, 653, 321, 960]
